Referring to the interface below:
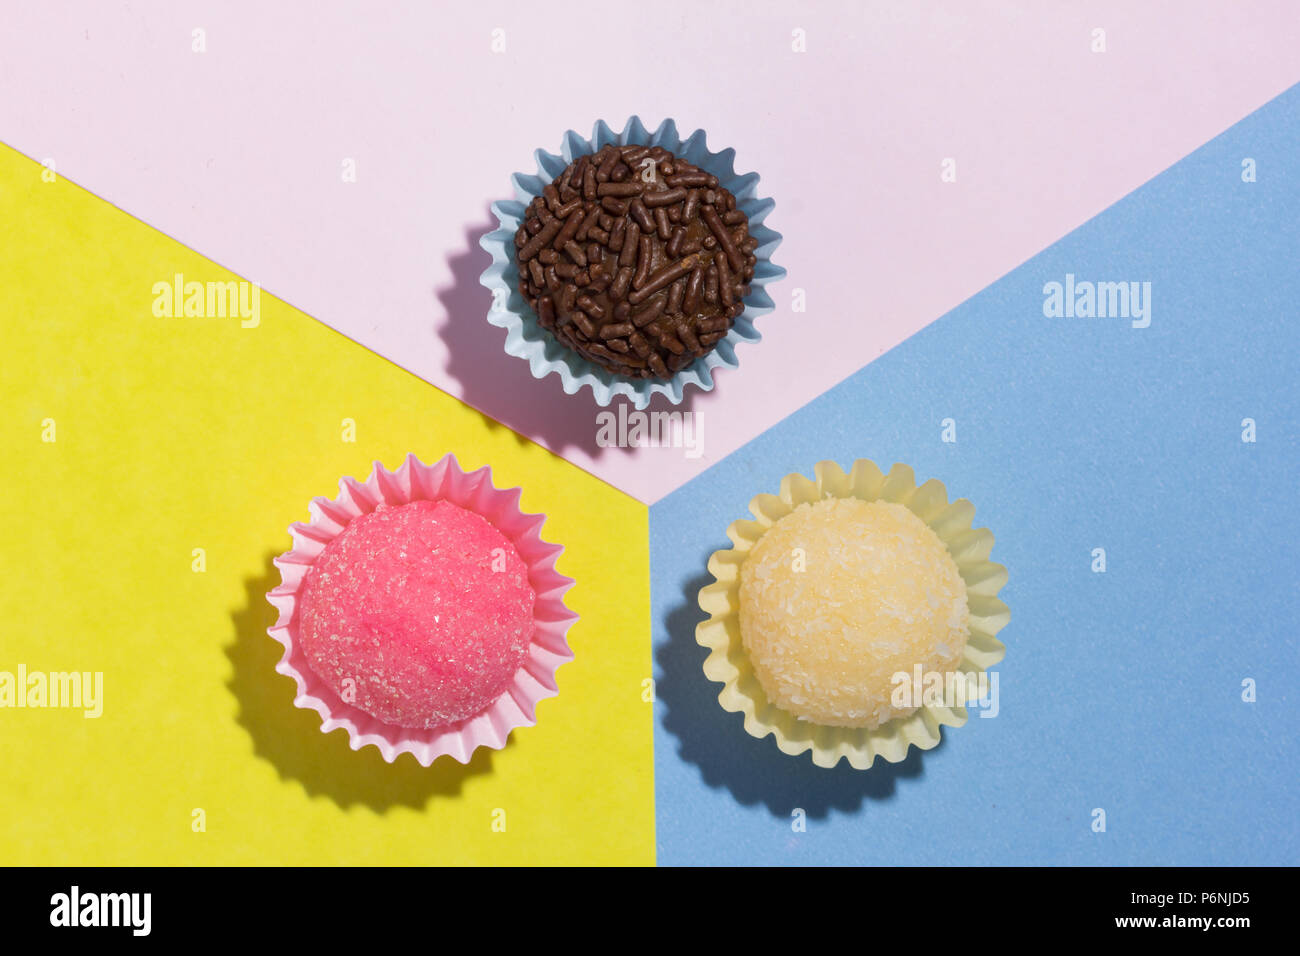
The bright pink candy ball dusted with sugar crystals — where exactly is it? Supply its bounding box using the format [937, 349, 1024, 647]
[298, 501, 536, 730]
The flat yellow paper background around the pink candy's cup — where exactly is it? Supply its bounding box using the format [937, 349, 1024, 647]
[0, 141, 654, 865]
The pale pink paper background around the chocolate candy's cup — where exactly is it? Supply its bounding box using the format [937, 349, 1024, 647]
[0, 0, 1300, 502]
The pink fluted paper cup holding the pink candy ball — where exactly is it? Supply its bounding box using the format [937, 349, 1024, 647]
[267, 454, 577, 766]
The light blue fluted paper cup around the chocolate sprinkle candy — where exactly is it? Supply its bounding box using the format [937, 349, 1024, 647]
[480, 116, 785, 408]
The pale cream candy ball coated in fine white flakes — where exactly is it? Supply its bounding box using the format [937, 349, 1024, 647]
[740, 498, 970, 728]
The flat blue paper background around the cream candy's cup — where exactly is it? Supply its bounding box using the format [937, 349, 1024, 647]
[650, 87, 1300, 865]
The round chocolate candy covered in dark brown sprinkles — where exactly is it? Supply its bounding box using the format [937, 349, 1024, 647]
[515, 143, 759, 380]
